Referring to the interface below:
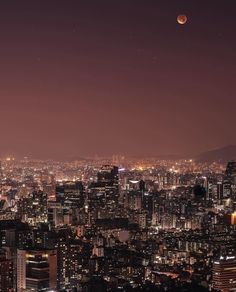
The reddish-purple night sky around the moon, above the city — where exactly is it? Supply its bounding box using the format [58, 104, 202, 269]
[0, 0, 236, 159]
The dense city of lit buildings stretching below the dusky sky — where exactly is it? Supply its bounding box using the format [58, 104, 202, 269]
[0, 155, 236, 292]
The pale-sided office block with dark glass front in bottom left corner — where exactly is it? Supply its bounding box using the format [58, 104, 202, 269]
[17, 249, 57, 292]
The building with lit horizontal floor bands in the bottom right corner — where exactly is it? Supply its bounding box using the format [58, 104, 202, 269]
[212, 255, 236, 292]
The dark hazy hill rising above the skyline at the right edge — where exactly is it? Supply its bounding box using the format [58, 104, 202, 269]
[195, 145, 236, 163]
